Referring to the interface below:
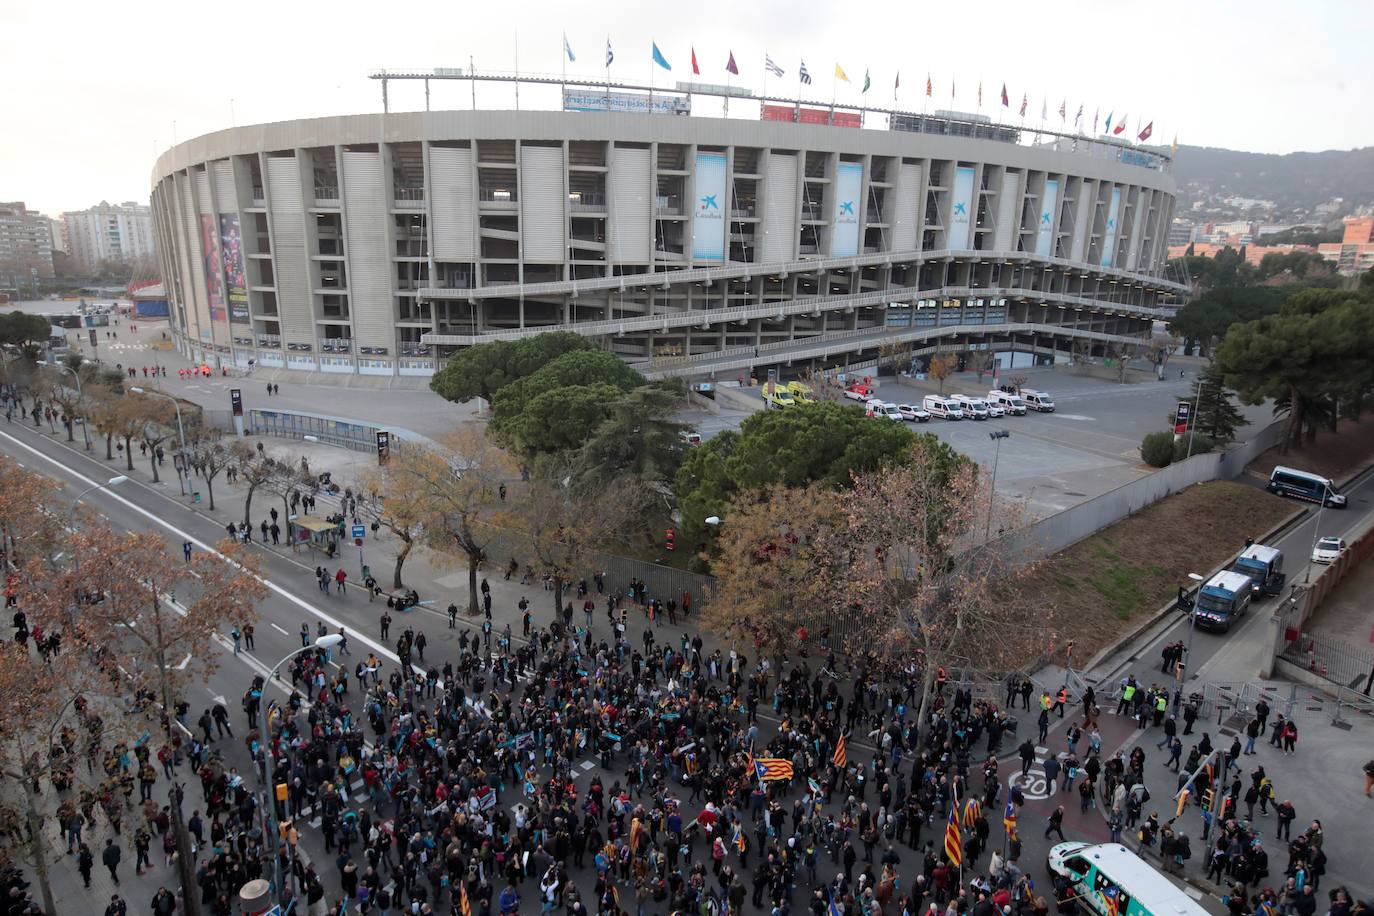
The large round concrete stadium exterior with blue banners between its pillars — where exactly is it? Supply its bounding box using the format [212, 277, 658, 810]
[153, 111, 1186, 380]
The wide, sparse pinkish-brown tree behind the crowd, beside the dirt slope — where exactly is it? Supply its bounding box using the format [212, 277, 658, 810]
[816, 450, 1033, 736]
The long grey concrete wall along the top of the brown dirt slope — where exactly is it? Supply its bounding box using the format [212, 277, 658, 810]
[1006, 420, 1286, 563]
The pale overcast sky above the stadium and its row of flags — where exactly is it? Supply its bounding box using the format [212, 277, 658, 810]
[0, 0, 1374, 214]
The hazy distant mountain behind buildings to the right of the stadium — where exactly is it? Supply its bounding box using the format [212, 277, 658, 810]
[1175, 146, 1374, 213]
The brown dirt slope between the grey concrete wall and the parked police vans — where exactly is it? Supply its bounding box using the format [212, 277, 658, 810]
[1017, 481, 1296, 663]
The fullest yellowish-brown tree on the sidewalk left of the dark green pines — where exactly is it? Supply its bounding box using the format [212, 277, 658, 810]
[382, 424, 519, 617]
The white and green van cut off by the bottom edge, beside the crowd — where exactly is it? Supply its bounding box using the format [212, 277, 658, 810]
[1047, 842, 1206, 916]
